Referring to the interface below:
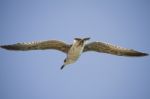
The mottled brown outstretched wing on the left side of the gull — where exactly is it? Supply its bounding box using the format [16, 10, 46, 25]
[0, 40, 71, 53]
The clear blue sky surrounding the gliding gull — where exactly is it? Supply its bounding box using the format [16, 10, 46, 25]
[0, 0, 150, 99]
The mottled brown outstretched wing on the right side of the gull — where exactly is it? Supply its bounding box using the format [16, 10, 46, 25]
[84, 42, 148, 56]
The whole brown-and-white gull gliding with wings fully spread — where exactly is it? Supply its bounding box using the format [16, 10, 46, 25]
[0, 37, 148, 70]
